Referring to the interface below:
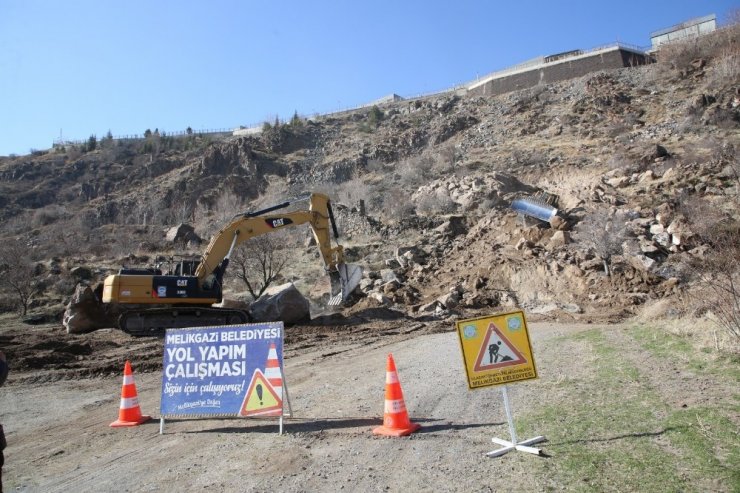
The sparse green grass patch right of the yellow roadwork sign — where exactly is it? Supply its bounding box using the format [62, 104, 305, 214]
[517, 328, 740, 492]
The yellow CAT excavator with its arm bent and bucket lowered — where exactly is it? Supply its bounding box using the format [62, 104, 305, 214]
[102, 193, 362, 336]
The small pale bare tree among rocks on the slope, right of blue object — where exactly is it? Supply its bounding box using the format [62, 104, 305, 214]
[574, 209, 629, 277]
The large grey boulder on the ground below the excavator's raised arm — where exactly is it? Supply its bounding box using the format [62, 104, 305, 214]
[249, 283, 311, 325]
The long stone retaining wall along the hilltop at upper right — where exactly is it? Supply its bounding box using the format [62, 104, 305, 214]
[468, 46, 649, 96]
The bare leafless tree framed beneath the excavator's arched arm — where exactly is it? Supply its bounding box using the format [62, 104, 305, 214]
[231, 235, 288, 300]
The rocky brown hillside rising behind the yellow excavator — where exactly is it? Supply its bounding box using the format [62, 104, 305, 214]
[0, 26, 740, 328]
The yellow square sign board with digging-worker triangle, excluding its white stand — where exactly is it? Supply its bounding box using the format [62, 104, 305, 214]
[456, 311, 537, 389]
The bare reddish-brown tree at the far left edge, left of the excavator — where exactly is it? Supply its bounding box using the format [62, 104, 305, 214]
[0, 238, 37, 315]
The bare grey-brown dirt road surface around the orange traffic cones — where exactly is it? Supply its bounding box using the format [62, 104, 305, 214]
[0, 314, 588, 491]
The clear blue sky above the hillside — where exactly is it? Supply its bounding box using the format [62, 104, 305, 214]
[0, 0, 740, 155]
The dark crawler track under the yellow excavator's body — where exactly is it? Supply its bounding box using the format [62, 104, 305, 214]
[118, 306, 250, 337]
